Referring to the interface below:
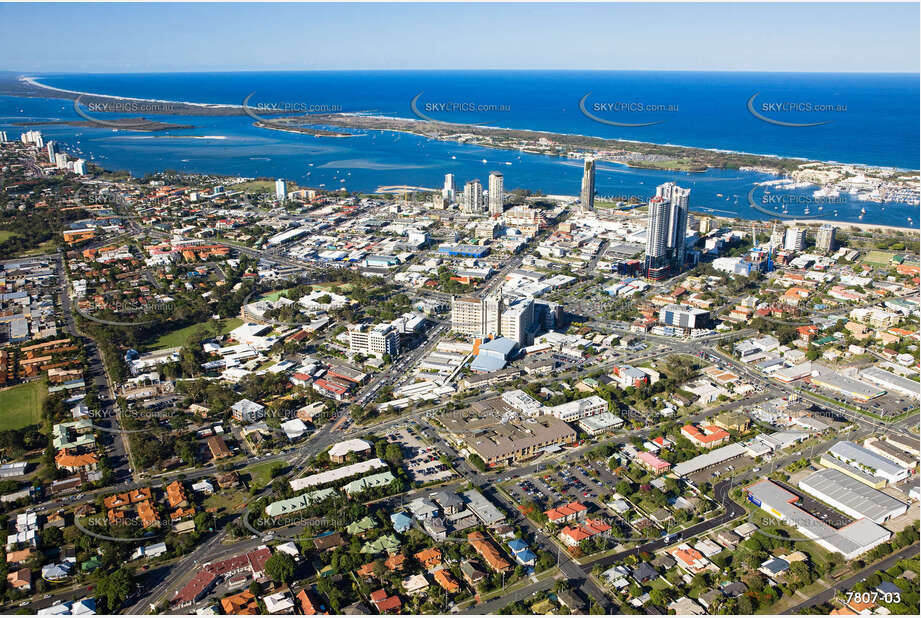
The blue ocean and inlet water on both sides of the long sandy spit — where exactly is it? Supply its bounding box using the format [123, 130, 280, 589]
[0, 71, 919, 227]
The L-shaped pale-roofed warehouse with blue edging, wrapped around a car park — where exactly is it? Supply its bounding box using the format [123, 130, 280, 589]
[746, 480, 892, 560]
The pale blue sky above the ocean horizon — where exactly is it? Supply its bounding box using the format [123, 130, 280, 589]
[0, 3, 919, 73]
